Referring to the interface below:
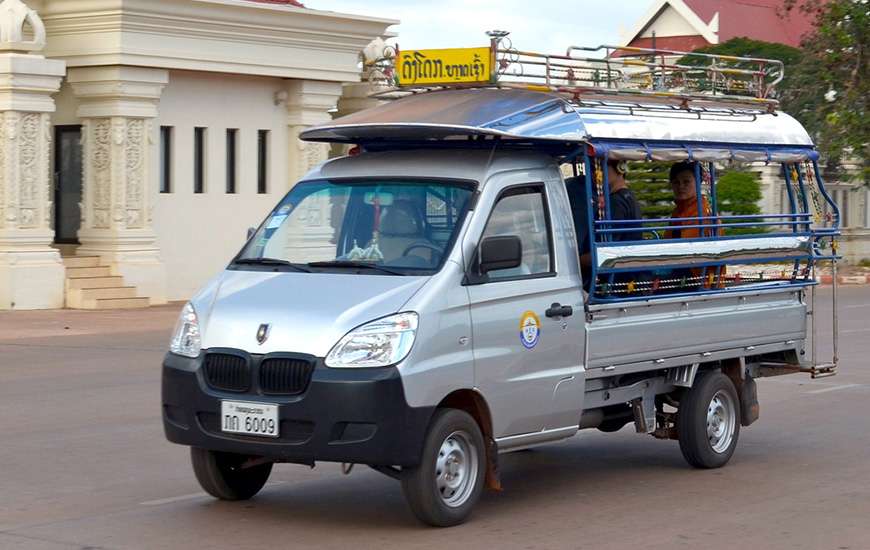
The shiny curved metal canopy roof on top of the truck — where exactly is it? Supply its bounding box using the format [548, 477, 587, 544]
[300, 88, 813, 152]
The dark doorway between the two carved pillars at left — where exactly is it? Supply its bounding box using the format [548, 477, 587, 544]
[54, 126, 82, 244]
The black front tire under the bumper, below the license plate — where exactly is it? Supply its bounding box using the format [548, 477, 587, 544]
[190, 447, 272, 500]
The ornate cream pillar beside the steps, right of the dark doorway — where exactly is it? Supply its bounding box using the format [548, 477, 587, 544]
[69, 65, 169, 304]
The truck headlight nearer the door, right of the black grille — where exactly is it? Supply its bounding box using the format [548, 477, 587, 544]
[326, 312, 417, 368]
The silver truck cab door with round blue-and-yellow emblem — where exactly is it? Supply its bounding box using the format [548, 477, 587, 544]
[468, 180, 585, 438]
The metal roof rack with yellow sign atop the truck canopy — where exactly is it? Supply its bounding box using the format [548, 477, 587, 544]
[366, 31, 784, 118]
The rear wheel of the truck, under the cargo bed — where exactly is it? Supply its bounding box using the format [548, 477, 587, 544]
[677, 372, 740, 468]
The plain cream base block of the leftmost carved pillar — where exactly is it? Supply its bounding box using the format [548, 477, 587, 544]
[0, 247, 65, 310]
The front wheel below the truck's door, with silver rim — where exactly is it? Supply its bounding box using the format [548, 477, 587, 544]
[402, 409, 486, 527]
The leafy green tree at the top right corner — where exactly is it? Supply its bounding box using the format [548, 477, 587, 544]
[783, 0, 870, 183]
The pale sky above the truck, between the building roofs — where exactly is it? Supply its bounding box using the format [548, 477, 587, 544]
[303, 0, 654, 54]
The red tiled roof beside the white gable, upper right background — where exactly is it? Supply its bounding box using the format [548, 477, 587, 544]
[684, 0, 813, 46]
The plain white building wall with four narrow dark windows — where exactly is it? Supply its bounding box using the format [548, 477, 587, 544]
[152, 71, 294, 300]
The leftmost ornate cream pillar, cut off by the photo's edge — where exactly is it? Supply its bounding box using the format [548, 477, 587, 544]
[0, 0, 66, 310]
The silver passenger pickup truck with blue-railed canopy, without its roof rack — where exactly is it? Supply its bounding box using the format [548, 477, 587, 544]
[162, 47, 836, 526]
